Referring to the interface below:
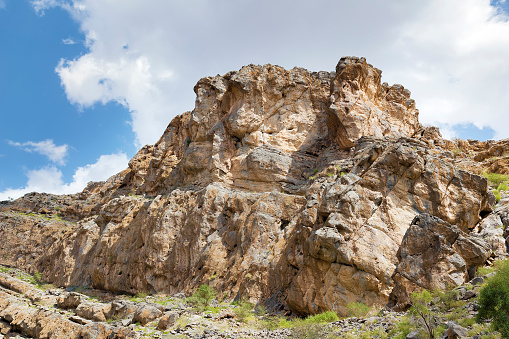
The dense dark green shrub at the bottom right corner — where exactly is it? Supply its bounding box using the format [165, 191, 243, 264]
[477, 260, 509, 338]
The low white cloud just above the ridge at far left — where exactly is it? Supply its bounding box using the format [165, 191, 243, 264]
[0, 153, 129, 201]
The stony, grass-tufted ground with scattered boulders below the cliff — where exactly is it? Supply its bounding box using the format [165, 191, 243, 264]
[0, 267, 499, 339]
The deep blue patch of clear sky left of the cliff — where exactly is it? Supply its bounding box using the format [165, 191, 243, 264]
[0, 0, 137, 199]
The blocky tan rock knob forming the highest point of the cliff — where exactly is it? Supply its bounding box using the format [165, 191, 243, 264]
[330, 57, 420, 148]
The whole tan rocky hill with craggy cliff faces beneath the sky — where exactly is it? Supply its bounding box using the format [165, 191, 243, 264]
[0, 57, 509, 338]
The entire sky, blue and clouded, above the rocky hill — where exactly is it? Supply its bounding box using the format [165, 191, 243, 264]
[0, 0, 509, 200]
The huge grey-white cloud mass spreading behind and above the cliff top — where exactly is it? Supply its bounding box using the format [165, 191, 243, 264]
[33, 0, 509, 145]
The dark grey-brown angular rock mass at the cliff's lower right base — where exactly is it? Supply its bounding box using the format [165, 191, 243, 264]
[391, 213, 492, 309]
